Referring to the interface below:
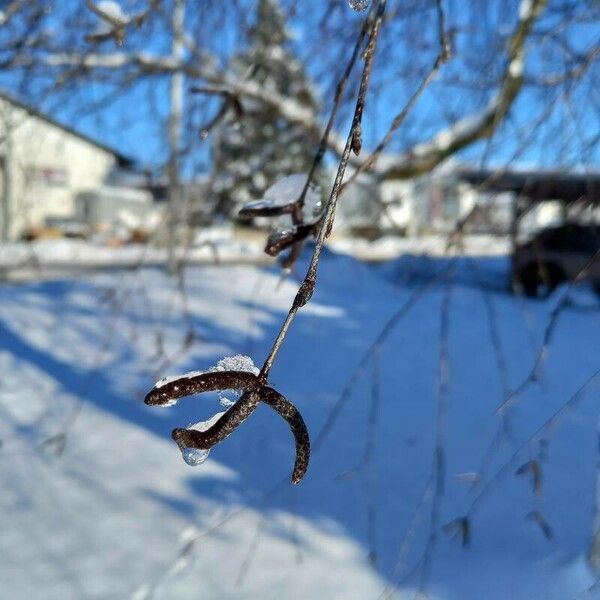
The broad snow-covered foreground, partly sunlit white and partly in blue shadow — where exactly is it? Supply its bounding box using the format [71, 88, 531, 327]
[0, 252, 600, 600]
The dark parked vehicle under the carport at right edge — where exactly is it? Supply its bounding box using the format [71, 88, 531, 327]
[513, 224, 600, 298]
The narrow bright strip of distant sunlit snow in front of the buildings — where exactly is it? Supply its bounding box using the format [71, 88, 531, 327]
[0, 233, 509, 281]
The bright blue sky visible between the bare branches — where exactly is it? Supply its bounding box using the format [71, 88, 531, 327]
[3, 0, 600, 171]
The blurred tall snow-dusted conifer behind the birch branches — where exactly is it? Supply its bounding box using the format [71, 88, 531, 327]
[213, 0, 319, 215]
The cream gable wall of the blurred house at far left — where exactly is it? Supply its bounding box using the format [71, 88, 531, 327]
[0, 98, 115, 238]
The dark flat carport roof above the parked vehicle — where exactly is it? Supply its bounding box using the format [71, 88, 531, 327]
[457, 168, 600, 203]
